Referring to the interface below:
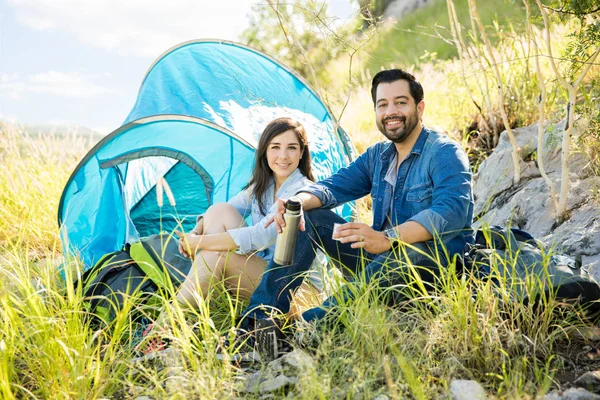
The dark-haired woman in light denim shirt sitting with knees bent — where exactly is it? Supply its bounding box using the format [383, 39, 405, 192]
[177, 118, 314, 307]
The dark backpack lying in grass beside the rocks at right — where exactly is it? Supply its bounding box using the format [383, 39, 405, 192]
[464, 226, 600, 315]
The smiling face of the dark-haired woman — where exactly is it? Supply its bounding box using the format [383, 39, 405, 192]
[267, 129, 302, 181]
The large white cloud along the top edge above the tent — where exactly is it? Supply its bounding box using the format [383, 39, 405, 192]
[8, 0, 254, 57]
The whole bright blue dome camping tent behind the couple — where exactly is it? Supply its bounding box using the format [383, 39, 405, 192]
[58, 40, 355, 268]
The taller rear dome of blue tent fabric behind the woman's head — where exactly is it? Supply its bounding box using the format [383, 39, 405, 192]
[125, 40, 355, 179]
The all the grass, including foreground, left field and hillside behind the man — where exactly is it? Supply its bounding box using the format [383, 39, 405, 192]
[0, 0, 600, 399]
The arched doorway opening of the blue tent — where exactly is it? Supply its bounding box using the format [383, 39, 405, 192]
[100, 147, 214, 242]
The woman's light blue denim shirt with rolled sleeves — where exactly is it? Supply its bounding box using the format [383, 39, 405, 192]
[227, 169, 313, 262]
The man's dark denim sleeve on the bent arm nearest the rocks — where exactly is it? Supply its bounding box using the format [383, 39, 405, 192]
[409, 143, 473, 237]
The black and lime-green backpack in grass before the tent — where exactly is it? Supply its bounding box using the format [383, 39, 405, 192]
[75, 234, 192, 323]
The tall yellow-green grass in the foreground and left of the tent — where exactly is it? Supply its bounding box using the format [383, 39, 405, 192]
[0, 123, 600, 399]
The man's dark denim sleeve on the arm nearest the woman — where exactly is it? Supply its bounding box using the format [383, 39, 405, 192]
[299, 147, 373, 208]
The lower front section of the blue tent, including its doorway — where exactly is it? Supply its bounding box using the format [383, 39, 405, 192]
[59, 116, 254, 267]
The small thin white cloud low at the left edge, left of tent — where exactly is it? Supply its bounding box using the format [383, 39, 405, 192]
[0, 71, 119, 99]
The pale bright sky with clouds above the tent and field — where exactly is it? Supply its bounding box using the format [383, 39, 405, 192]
[0, 0, 355, 134]
